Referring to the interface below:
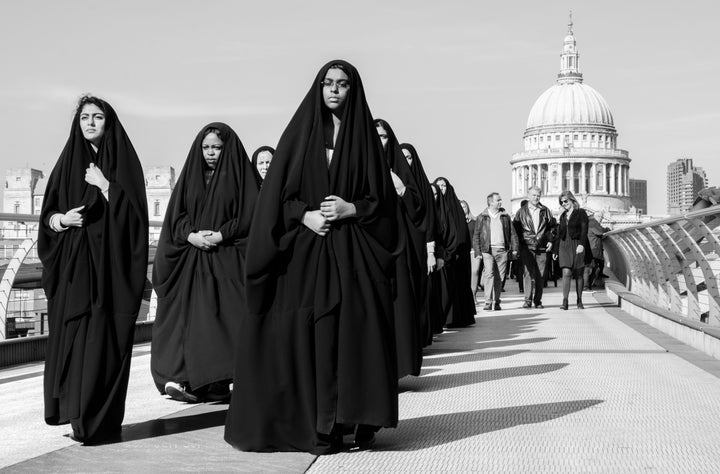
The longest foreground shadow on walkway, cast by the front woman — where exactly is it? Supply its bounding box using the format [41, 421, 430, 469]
[380, 399, 604, 451]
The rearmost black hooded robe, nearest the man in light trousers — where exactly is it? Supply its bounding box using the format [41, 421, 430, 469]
[435, 177, 477, 327]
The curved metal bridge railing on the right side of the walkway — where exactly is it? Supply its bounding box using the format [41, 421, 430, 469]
[605, 205, 720, 326]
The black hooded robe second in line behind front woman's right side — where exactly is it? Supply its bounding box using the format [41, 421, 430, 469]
[400, 143, 443, 346]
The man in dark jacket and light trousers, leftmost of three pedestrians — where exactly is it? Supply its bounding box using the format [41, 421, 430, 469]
[473, 193, 518, 311]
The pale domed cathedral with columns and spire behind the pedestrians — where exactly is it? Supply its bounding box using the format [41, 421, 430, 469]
[510, 13, 631, 213]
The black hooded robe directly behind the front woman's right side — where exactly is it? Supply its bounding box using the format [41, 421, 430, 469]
[375, 119, 427, 377]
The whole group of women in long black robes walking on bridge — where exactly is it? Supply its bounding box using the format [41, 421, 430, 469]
[38, 60, 474, 454]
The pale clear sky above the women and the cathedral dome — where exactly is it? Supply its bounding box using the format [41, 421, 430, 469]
[0, 0, 720, 215]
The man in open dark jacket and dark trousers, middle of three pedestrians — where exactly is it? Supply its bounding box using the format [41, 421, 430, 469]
[513, 186, 555, 308]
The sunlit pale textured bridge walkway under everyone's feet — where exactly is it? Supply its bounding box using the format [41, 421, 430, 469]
[0, 284, 720, 473]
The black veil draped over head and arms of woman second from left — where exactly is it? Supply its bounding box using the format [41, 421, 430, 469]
[153, 122, 260, 296]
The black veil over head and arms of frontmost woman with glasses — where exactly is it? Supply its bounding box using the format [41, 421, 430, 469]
[247, 60, 398, 313]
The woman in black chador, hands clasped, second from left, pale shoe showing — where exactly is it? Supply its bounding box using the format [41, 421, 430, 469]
[151, 123, 259, 402]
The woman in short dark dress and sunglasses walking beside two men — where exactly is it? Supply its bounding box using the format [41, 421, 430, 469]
[553, 191, 592, 309]
